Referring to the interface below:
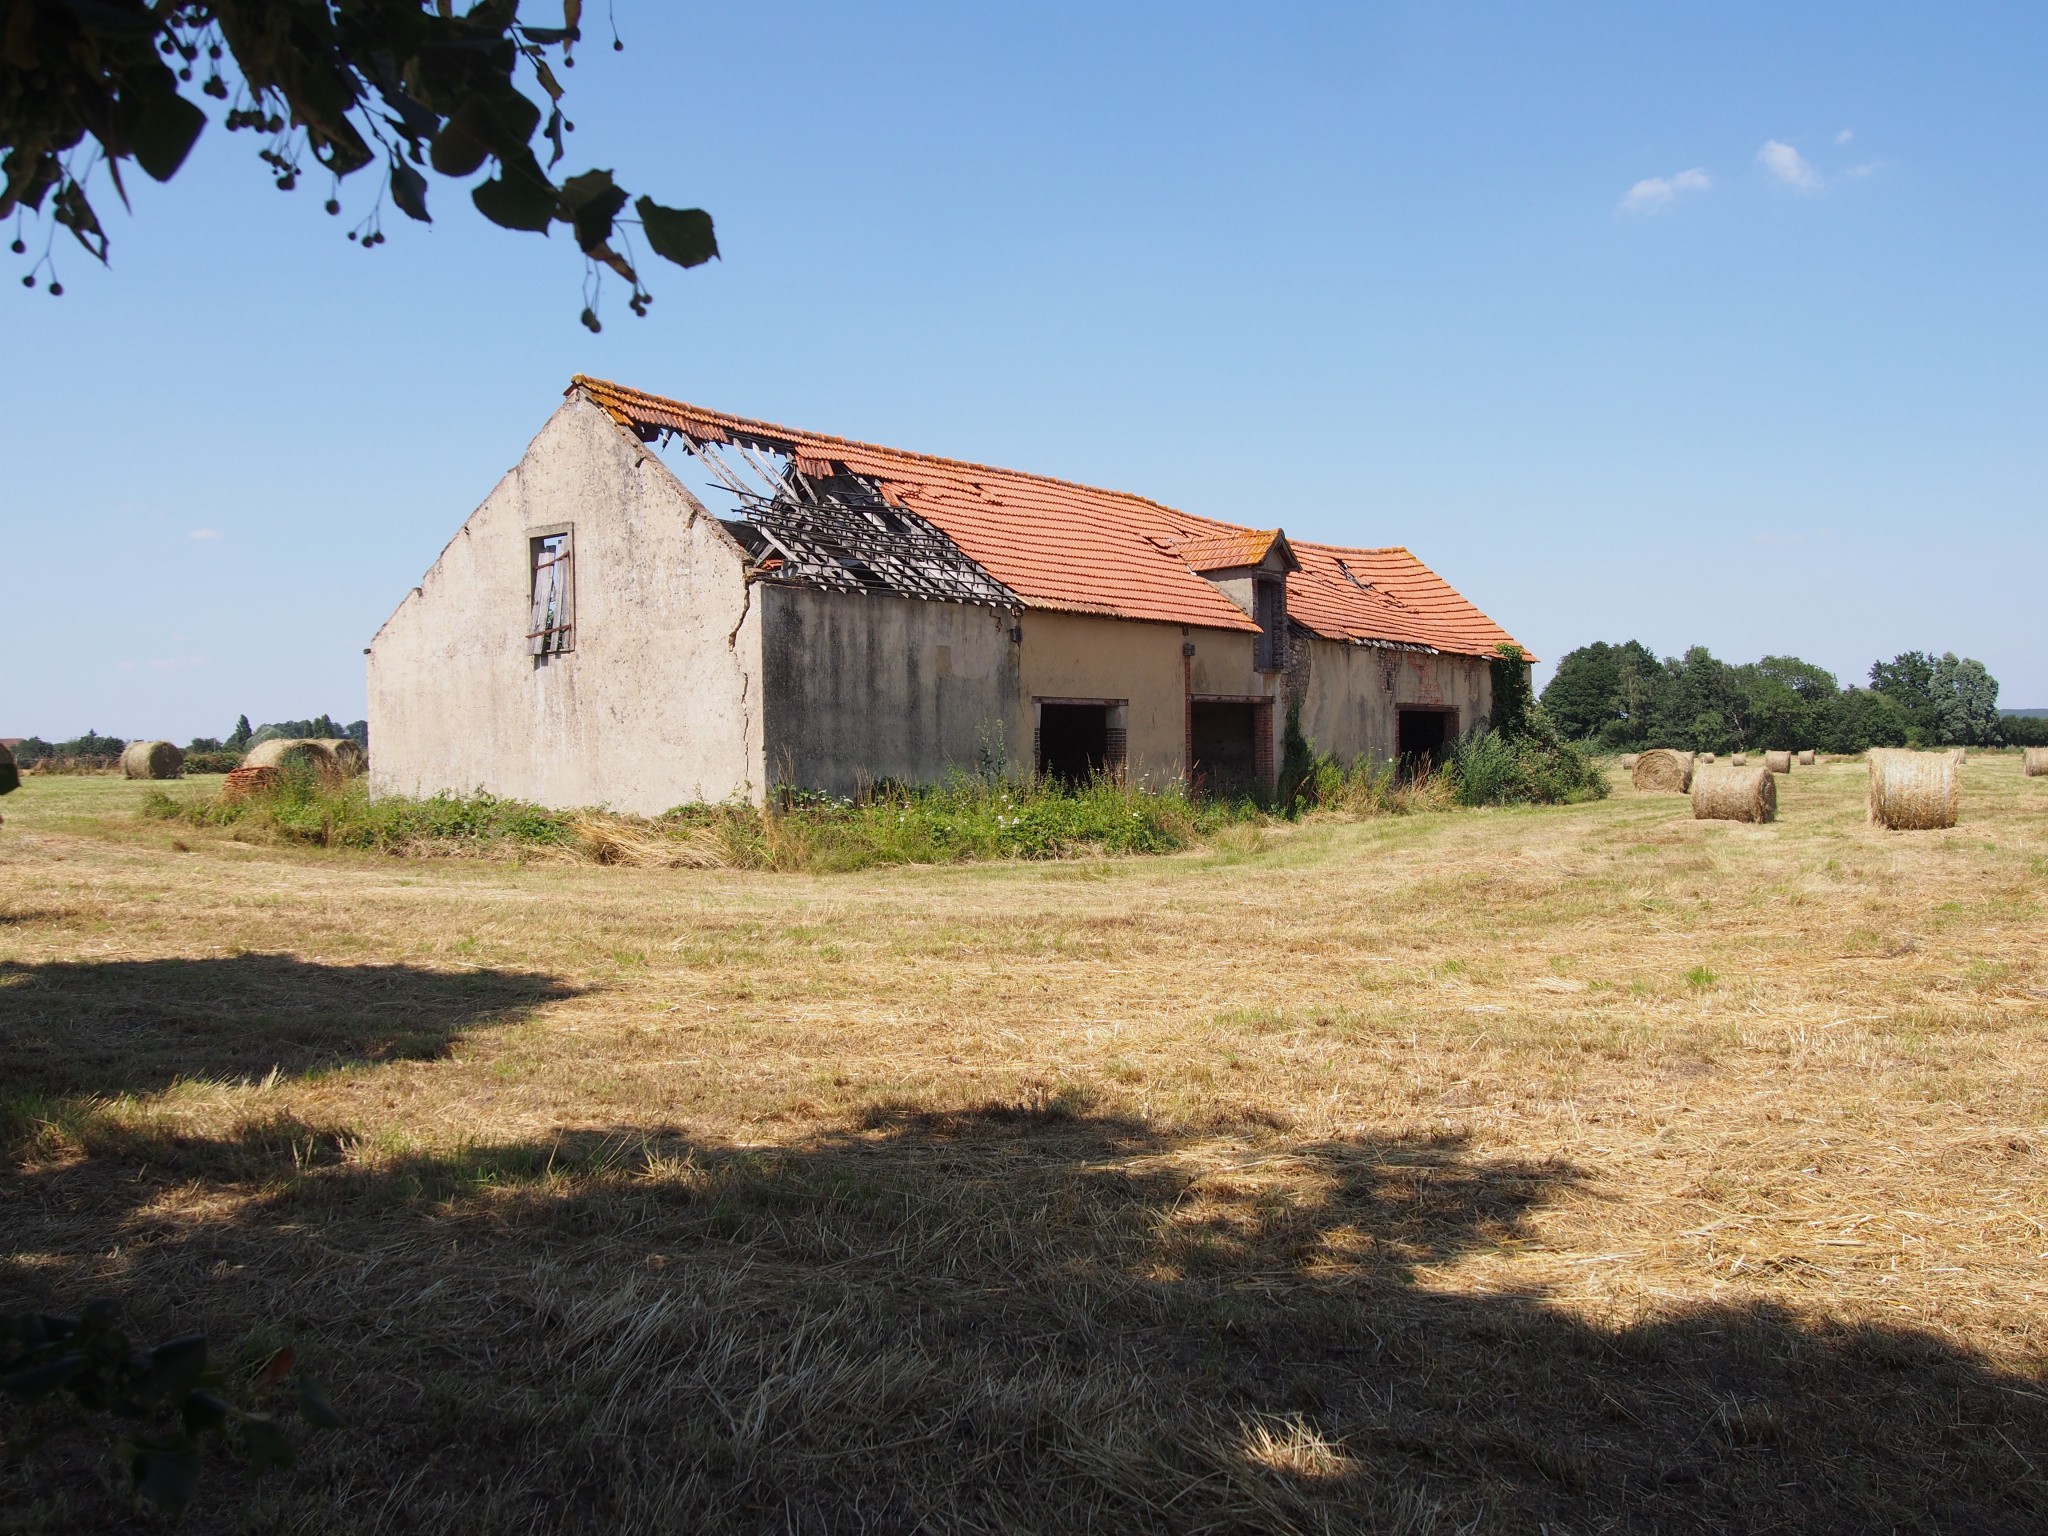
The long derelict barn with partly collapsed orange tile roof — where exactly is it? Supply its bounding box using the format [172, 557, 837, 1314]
[369, 377, 1509, 813]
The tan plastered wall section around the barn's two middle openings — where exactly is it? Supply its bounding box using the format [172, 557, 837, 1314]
[1012, 610, 1282, 786]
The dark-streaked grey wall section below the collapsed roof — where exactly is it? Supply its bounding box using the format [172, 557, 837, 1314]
[754, 582, 1030, 795]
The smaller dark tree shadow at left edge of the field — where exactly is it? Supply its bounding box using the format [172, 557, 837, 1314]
[0, 954, 578, 1096]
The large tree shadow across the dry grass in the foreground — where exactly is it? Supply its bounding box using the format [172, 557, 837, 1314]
[0, 1102, 2048, 1536]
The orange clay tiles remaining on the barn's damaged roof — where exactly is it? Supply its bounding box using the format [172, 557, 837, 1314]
[569, 375, 1509, 655]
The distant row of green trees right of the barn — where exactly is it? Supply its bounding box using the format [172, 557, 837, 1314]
[1542, 641, 2048, 752]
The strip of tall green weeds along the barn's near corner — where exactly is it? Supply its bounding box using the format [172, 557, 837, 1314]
[143, 770, 1264, 870]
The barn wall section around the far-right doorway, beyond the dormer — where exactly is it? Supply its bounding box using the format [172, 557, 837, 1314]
[1302, 639, 1493, 762]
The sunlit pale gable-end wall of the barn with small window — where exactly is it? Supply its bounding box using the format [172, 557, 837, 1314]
[369, 397, 766, 813]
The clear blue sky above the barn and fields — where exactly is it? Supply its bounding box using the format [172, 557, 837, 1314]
[0, 0, 2048, 739]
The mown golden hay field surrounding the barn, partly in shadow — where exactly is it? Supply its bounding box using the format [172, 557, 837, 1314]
[0, 754, 2048, 1534]
